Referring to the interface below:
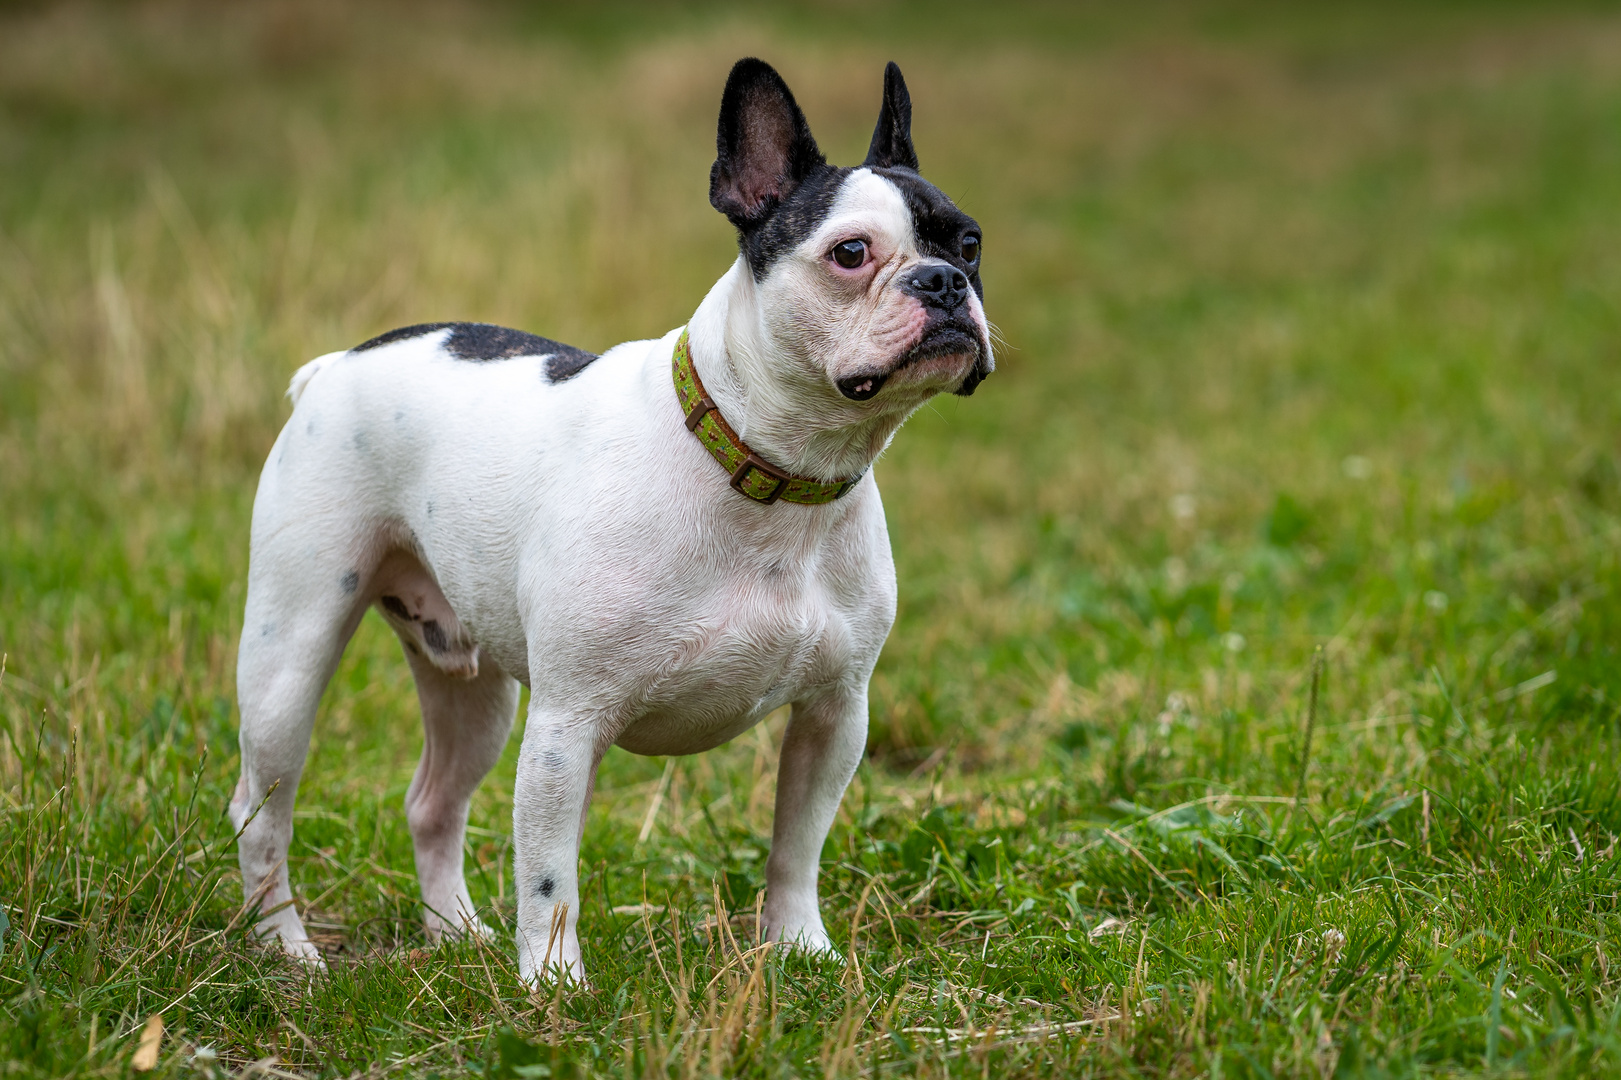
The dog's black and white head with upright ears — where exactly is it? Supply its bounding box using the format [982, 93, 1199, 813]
[710, 58, 994, 415]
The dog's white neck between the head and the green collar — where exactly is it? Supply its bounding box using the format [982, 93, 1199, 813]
[687, 256, 909, 480]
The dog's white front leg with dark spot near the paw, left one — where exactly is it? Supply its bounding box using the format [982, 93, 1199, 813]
[512, 704, 601, 984]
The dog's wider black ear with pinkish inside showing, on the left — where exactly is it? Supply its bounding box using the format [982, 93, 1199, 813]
[710, 57, 827, 232]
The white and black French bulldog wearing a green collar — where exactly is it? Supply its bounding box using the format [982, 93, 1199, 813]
[230, 58, 995, 984]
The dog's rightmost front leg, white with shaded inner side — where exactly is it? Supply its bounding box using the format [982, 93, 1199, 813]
[763, 686, 867, 952]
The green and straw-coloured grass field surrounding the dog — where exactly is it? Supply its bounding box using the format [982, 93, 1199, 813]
[0, 0, 1621, 1078]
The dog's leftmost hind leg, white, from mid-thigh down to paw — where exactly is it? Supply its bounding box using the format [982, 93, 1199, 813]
[230, 530, 365, 966]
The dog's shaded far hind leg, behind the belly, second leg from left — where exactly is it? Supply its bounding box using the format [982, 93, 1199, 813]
[402, 634, 517, 941]
